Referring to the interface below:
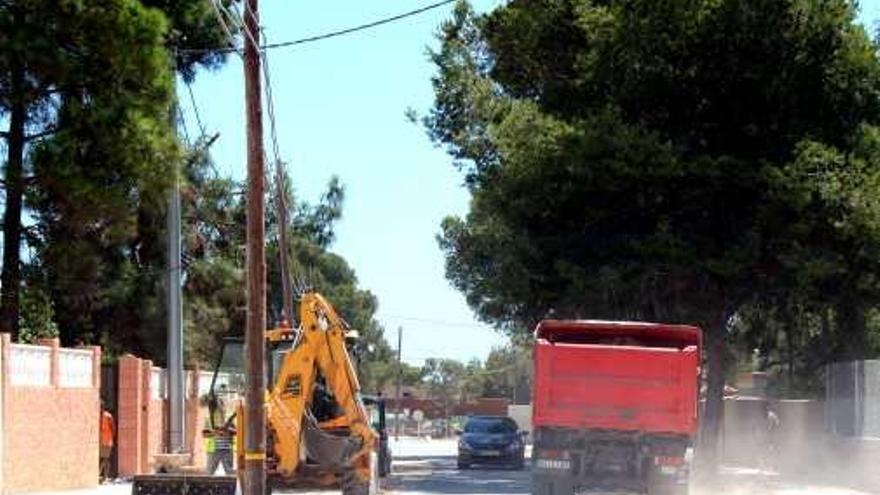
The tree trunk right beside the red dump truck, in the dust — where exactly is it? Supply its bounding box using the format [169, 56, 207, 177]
[697, 317, 727, 478]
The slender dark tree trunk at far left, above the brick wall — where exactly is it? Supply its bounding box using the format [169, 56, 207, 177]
[0, 54, 27, 341]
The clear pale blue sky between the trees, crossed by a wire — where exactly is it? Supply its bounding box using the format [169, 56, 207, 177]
[180, 0, 880, 364]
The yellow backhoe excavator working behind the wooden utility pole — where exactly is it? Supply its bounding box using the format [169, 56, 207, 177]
[132, 292, 390, 495]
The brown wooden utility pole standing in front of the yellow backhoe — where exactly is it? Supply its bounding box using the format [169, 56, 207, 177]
[243, 0, 266, 495]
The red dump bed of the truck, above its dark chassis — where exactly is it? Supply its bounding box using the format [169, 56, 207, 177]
[532, 320, 701, 436]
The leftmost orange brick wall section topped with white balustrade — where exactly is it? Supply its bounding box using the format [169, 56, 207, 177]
[0, 334, 101, 494]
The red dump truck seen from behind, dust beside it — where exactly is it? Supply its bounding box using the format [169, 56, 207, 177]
[532, 320, 701, 495]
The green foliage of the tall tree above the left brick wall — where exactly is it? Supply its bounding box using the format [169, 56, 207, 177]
[0, 0, 232, 340]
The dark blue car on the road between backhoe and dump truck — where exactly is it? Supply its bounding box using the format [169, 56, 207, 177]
[458, 416, 525, 469]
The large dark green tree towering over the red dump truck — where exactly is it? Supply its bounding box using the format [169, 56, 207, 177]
[424, 0, 880, 470]
